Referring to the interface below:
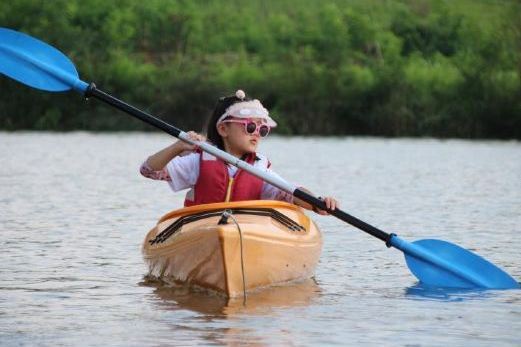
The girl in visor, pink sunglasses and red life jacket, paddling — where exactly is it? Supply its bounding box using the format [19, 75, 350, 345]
[140, 90, 338, 215]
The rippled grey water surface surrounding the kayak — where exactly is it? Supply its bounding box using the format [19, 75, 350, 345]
[0, 132, 521, 346]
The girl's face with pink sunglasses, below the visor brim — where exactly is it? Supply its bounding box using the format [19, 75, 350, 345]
[218, 118, 269, 155]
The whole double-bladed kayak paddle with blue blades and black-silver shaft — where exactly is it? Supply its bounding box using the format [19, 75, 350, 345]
[0, 28, 519, 289]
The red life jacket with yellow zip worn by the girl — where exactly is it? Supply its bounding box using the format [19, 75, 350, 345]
[185, 152, 270, 207]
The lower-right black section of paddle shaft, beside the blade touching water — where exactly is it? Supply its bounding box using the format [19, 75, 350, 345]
[293, 188, 394, 243]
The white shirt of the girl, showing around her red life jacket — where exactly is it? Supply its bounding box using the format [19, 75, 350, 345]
[166, 153, 293, 203]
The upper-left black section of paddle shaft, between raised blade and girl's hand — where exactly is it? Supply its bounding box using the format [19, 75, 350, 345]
[85, 83, 181, 138]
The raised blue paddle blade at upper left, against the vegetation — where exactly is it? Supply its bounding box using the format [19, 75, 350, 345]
[0, 28, 89, 93]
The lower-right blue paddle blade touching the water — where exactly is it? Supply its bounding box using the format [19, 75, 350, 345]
[391, 236, 520, 289]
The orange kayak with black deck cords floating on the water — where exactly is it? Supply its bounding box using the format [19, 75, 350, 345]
[143, 200, 322, 297]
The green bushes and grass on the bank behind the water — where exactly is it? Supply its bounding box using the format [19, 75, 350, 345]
[0, 0, 521, 139]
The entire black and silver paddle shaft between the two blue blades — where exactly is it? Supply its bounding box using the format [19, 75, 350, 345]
[85, 83, 393, 245]
